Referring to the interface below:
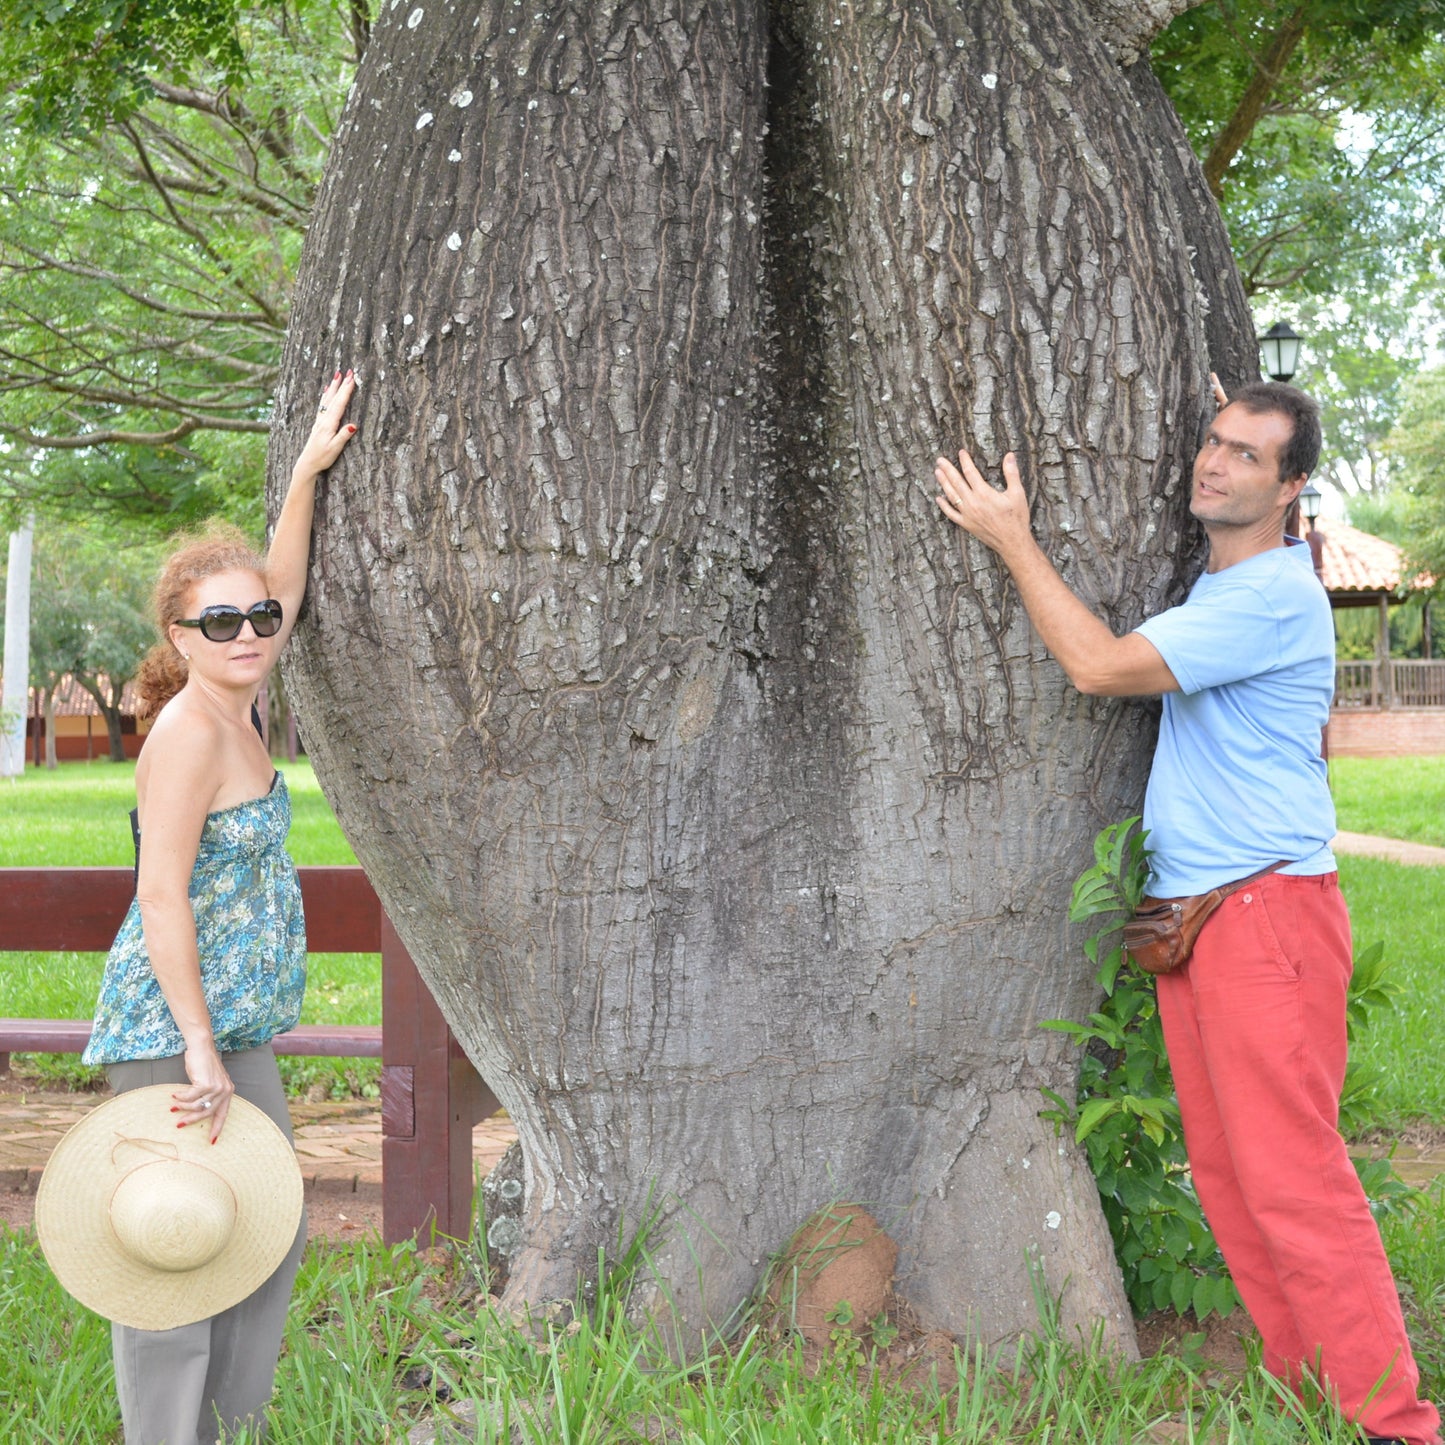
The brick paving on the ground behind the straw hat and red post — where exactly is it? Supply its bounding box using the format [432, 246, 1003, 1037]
[0, 1092, 517, 1194]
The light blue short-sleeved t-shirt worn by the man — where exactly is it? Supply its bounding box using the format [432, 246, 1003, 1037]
[1139, 545, 1335, 897]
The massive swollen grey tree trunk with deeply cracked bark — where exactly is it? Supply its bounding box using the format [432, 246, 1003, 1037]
[272, 0, 1247, 1341]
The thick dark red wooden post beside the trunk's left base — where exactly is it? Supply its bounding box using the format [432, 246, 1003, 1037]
[381, 912, 497, 1244]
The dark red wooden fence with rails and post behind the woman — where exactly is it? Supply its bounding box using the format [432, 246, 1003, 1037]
[0, 867, 497, 1244]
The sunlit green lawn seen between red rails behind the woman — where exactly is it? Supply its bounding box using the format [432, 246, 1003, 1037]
[0, 759, 381, 1095]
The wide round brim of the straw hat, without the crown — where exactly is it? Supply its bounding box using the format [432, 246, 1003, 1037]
[35, 1084, 305, 1329]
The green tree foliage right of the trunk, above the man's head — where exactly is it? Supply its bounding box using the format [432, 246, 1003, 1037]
[1152, 0, 1445, 502]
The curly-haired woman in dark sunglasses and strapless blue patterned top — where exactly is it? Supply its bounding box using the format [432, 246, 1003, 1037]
[85, 371, 355, 1445]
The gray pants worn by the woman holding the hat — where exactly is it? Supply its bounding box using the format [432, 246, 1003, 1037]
[105, 1046, 306, 1445]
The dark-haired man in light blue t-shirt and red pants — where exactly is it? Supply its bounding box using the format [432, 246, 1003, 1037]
[933, 383, 1441, 1445]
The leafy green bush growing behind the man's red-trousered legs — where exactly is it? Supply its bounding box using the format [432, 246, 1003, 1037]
[1042, 818, 1412, 1319]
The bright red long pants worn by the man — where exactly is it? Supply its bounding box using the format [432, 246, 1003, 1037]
[1159, 873, 1439, 1445]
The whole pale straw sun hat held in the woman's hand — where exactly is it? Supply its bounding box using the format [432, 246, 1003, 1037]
[35, 1084, 302, 1329]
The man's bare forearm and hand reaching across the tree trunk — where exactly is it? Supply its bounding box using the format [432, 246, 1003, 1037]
[933, 451, 1179, 698]
